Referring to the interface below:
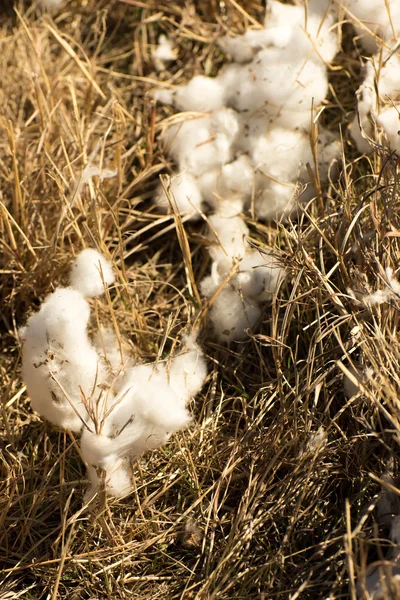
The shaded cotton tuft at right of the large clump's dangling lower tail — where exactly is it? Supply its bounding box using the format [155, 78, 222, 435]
[232, 250, 285, 302]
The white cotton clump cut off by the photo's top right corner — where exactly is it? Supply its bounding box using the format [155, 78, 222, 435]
[343, 0, 400, 54]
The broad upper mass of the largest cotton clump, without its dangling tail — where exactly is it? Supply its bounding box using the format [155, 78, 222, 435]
[156, 0, 340, 218]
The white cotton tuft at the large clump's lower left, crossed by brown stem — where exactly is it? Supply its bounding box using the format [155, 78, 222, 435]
[155, 172, 202, 220]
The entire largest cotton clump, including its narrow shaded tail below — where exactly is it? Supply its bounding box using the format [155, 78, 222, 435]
[156, 0, 340, 342]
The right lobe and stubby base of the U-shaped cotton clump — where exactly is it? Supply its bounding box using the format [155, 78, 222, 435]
[81, 338, 207, 496]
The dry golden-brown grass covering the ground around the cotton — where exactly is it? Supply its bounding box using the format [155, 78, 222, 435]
[0, 0, 400, 600]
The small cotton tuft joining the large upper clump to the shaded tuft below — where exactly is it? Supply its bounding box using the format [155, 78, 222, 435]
[208, 214, 249, 262]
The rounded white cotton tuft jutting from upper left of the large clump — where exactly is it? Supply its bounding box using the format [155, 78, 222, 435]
[174, 75, 224, 112]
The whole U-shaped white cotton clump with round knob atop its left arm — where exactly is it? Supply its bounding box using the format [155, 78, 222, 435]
[20, 249, 207, 496]
